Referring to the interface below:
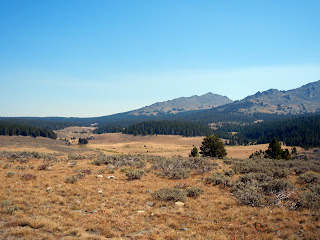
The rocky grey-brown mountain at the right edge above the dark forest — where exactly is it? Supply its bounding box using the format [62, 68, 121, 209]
[216, 80, 320, 114]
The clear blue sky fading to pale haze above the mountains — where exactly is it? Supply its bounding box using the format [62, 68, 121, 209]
[0, 0, 320, 117]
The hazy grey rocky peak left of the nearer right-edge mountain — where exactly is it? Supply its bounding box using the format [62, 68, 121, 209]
[130, 92, 232, 116]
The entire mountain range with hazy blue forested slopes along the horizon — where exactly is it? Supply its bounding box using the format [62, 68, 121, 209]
[0, 80, 320, 128]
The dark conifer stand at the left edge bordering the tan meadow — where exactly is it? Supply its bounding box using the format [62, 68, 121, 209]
[0, 122, 57, 139]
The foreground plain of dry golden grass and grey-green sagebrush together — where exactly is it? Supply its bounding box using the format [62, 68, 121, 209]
[0, 134, 320, 240]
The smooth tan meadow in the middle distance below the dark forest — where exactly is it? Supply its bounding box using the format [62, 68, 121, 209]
[88, 133, 301, 159]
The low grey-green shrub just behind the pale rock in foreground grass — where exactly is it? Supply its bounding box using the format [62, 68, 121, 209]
[151, 188, 187, 202]
